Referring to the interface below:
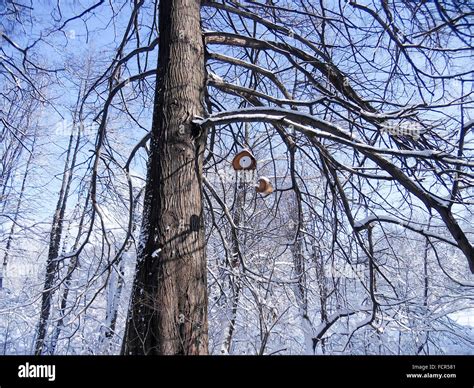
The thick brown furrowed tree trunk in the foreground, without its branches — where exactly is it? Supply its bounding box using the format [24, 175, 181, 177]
[122, 0, 208, 354]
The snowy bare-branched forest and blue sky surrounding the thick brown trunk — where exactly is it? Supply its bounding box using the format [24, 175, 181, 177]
[0, 0, 474, 355]
